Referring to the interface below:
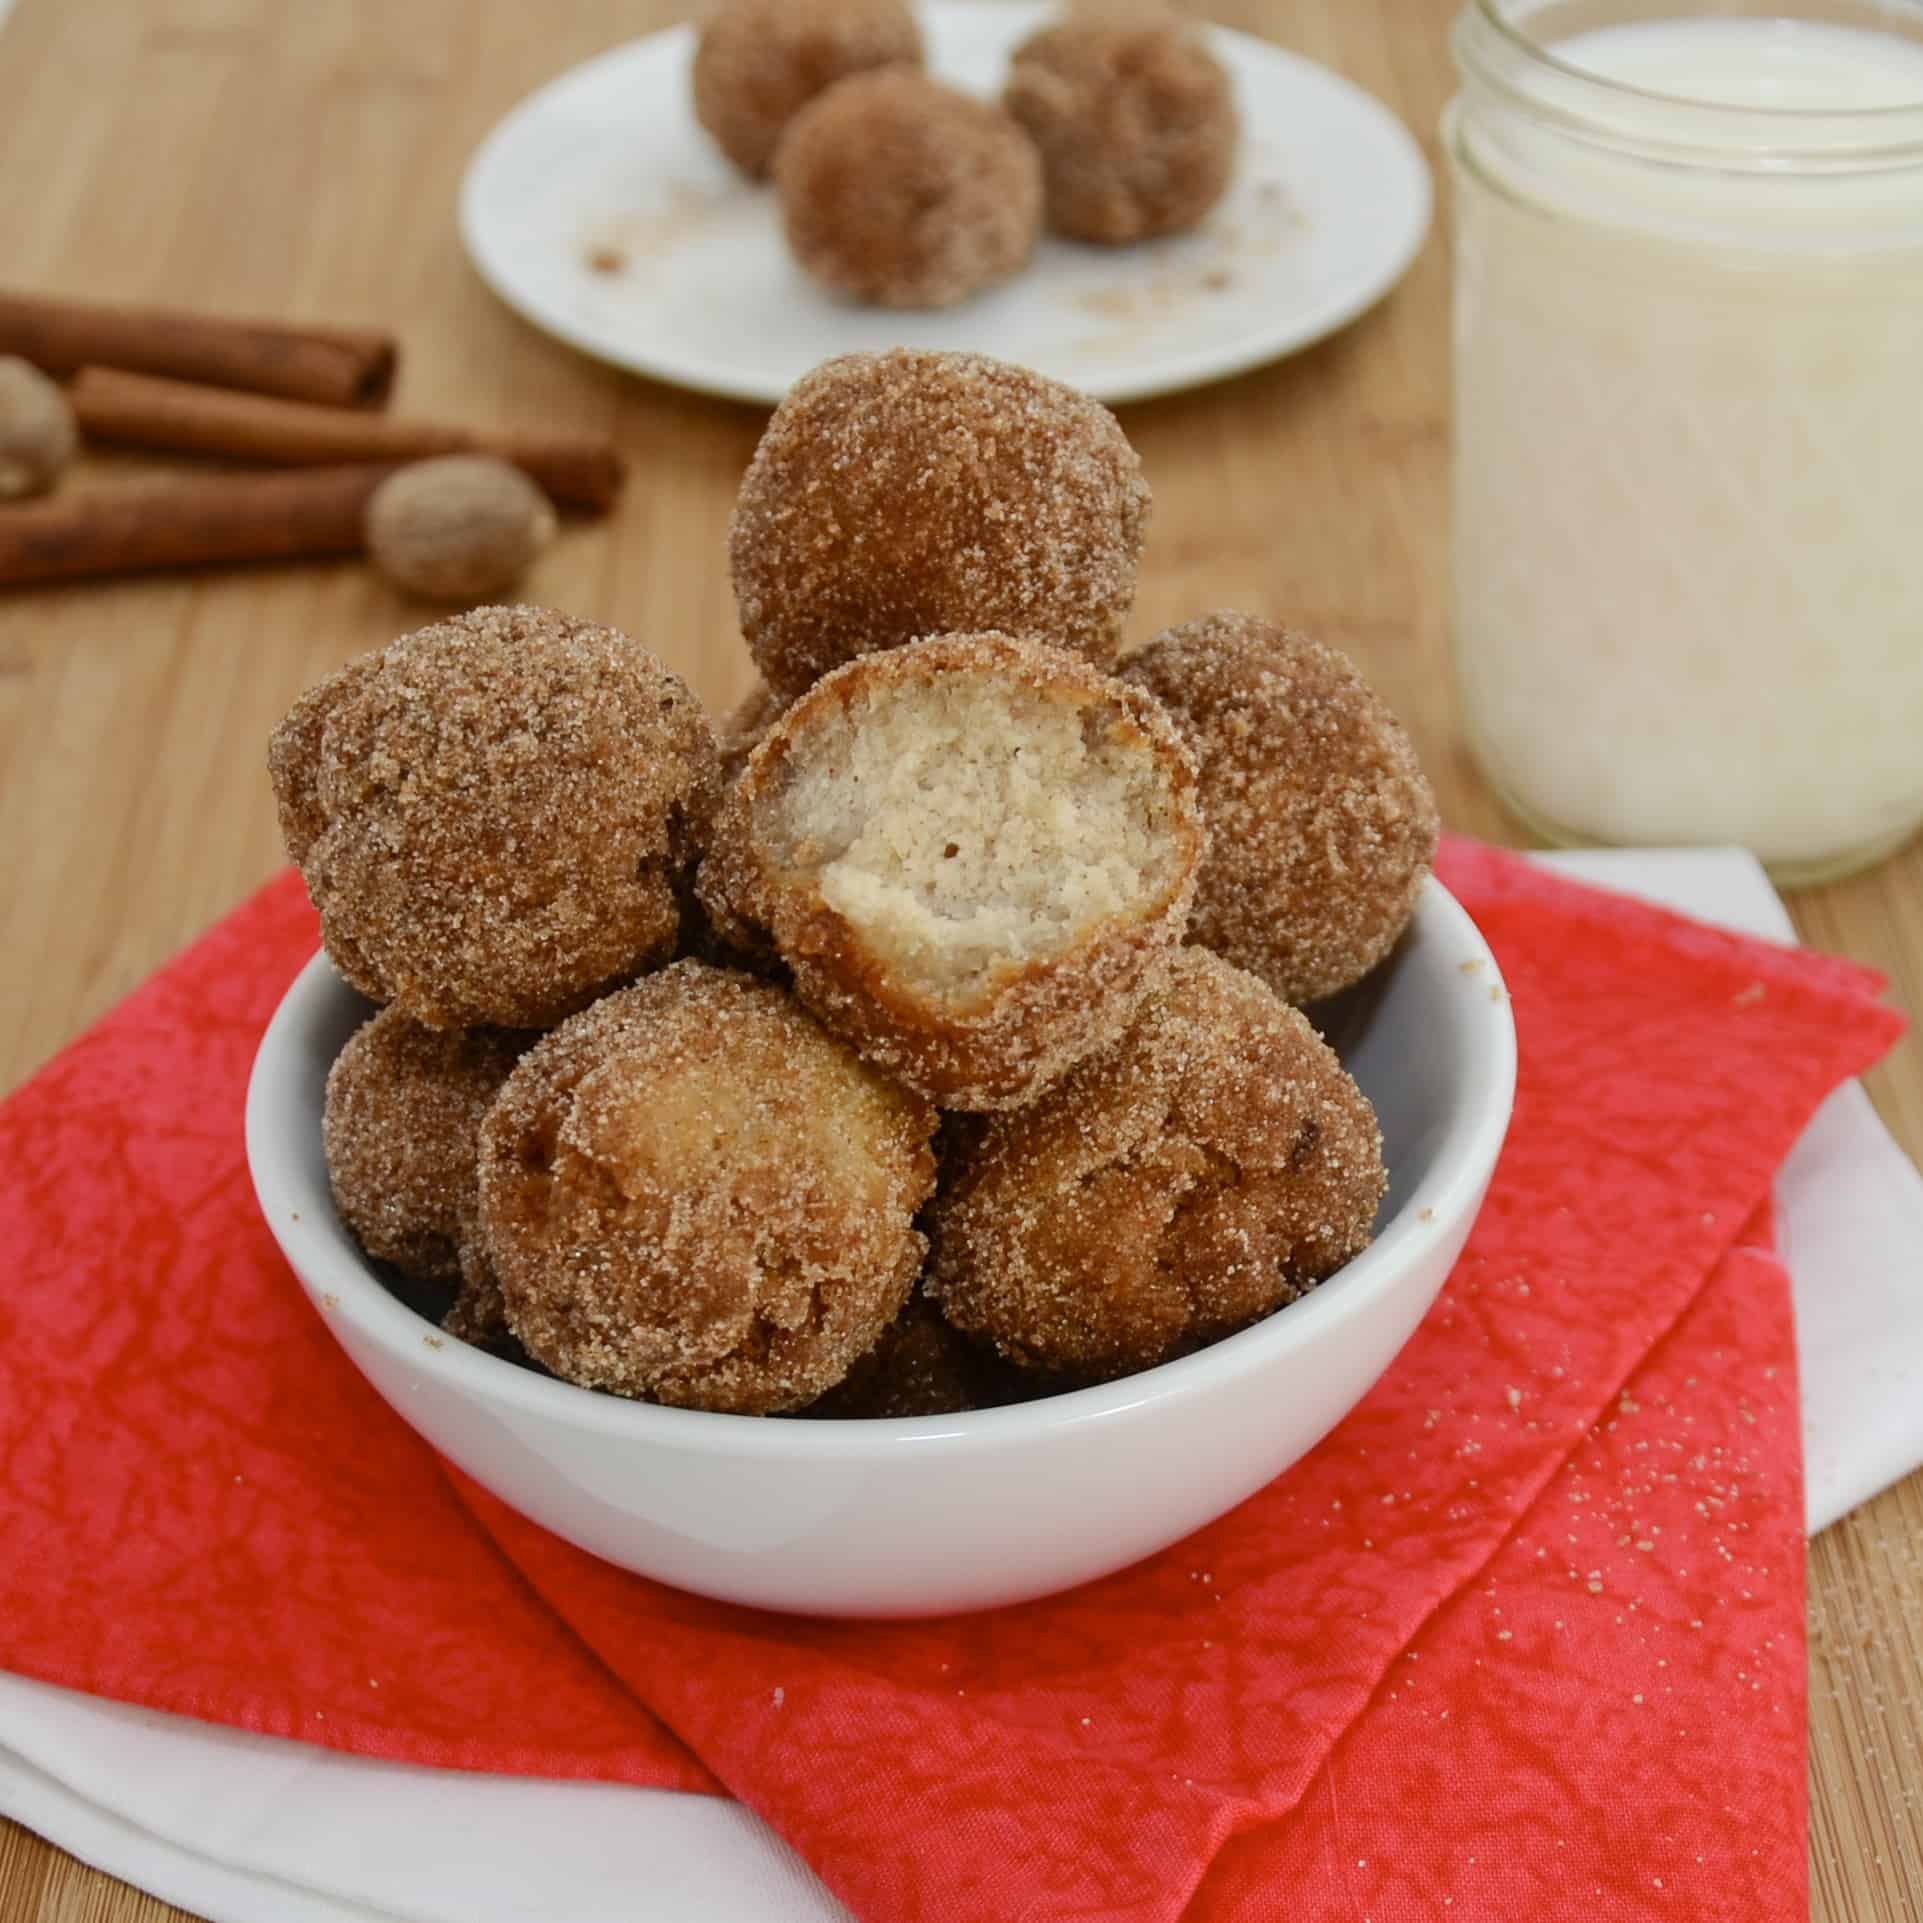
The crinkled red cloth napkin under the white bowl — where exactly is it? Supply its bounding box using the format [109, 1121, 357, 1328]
[0, 844, 1900, 1923]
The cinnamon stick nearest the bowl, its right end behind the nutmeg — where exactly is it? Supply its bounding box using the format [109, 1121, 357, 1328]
[0, 463, 394, 588]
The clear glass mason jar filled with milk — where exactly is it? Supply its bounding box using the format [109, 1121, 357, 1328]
[1444, 0, 1923, 883]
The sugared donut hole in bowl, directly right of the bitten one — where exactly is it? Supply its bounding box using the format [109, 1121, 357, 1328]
[1123, 613, 1440, 1006]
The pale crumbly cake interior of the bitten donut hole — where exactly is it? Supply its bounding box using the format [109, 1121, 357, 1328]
[756, 669, 1186, 1004]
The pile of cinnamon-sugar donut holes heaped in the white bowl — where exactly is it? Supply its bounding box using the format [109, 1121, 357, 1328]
[269, 350, 1436, 1417]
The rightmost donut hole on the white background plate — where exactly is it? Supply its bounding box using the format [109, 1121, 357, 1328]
[1004, 12, 1240, 244]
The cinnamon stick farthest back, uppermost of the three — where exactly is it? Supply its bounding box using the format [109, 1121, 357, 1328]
[0, 290, 398, 408]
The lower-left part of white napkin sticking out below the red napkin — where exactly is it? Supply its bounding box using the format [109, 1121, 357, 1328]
[0, 1671, 850, 1923]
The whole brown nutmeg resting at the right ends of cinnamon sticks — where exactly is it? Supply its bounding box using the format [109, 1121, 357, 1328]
[365, 454, 554, 604]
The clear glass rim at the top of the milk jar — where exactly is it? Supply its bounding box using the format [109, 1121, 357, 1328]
[1452, 0, 1923, 167]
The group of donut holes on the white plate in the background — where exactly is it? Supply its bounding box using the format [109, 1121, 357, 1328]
[692, 0, 1240, 308]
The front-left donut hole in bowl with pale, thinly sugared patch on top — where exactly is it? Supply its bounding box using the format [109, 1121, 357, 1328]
[479, 962, 935, 1415]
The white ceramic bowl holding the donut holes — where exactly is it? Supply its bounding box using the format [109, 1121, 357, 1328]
[246, 883, 1515, 1615]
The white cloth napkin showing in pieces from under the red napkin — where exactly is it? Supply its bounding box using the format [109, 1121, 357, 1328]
[0, 853, 1923, 1923]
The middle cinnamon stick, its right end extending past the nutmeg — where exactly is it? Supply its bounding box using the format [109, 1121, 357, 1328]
[67, 367, 623, 513]
